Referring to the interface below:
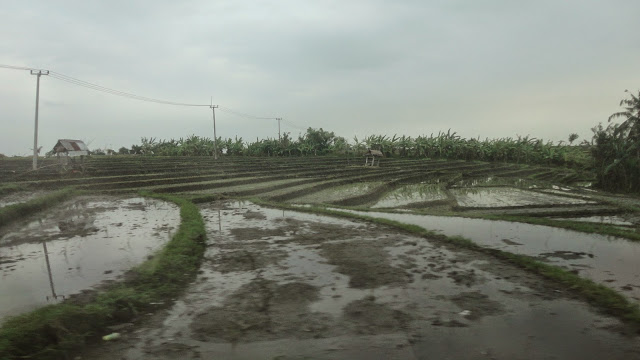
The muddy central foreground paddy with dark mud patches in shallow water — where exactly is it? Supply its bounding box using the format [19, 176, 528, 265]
[79, 203, 640, 360]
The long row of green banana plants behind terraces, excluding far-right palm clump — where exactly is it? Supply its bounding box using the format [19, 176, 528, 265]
[109, 128, 589, 167]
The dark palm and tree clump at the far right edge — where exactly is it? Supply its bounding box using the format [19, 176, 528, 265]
[591, 91, 640, 192]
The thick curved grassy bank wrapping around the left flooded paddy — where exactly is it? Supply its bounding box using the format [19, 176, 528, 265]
[0, 193, 206, 360]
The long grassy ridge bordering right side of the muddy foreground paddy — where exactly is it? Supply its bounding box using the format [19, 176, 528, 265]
[251, 199, 640, 331]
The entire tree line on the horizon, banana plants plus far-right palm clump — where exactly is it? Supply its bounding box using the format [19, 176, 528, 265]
[94, 91, 640, 192]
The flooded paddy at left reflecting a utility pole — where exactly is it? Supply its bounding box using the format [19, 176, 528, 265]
[0, 197, 179, 320]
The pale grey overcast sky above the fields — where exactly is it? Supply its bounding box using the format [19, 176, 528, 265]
[0, 0, 640, 155]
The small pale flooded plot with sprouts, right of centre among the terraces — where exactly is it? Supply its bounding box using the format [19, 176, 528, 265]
[450, 187, 595, 208]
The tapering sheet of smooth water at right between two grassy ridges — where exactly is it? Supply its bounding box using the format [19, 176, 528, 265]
[338, 210, 640, 301]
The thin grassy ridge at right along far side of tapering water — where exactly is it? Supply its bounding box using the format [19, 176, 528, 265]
[476, 215, 640, 241]
